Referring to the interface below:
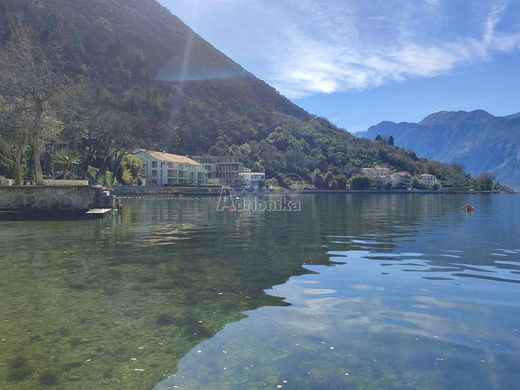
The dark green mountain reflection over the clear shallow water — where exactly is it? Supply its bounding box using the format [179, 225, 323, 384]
[0, 195, 472, 389]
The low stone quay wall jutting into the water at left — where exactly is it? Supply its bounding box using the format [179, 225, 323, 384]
[0, 186, 102, 211]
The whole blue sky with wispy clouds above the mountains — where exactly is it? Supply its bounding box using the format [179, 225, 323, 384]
[159, 0, 520, 131]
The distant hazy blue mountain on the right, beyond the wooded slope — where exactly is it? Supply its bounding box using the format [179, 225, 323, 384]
[362, 110, 520, 187]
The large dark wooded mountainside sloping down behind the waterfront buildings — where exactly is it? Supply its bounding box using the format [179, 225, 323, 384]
[0, 0, 478, 188]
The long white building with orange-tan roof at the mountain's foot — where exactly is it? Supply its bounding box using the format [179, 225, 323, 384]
[134, 150, 208, 187]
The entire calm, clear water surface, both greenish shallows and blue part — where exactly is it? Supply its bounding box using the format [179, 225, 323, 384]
[0, 194, 520, 390]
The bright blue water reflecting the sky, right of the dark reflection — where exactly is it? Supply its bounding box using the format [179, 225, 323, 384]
[154, 196, 520, 390]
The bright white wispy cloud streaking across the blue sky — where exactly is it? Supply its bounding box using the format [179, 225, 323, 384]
[269, 0, 520, 97]
